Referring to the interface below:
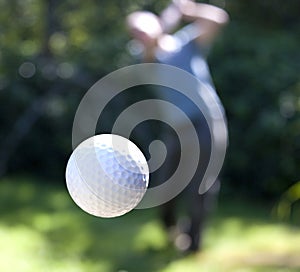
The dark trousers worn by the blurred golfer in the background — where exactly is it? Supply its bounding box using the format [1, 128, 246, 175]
[161, 116, 219, 251]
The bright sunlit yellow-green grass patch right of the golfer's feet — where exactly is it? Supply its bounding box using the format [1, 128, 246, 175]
[162, 218, 300, 272]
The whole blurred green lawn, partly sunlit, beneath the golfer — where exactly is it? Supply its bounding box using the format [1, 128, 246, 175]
[0, 176, 300, 272]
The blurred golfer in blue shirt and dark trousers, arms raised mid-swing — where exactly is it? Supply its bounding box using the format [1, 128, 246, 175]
[127, 0, 229, 251]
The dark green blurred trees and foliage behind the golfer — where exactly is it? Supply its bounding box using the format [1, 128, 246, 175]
[0, 0, 300, 196]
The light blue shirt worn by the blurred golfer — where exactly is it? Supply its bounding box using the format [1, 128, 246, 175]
[156, 24, 222, 126]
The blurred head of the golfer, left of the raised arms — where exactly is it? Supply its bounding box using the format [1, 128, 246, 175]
[126, 11, 162, 45]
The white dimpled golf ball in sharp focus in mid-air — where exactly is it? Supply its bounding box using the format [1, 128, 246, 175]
[66, 134, 149, 217]
